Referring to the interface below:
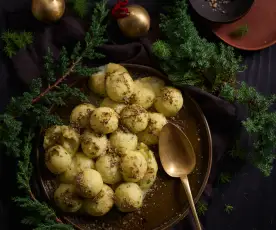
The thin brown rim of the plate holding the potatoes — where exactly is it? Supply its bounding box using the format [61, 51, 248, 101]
[36, 63, 212, 230]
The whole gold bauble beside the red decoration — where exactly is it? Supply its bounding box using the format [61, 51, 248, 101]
[118, 5, 150, 38]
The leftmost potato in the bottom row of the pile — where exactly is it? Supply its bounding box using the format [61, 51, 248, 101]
[54, 184, 83, 212]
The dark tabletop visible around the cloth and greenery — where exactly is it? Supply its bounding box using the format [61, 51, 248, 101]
[0, 0, 276, 230]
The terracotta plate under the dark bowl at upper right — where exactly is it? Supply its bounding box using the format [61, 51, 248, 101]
[212, 0, 276, 50]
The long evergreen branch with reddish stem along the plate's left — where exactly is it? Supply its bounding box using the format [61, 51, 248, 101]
[0, 2, 108, 230]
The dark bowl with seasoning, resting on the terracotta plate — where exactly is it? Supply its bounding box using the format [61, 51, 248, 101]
[189, 0, 254, 22]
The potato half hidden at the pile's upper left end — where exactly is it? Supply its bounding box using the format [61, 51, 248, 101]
[88, 67, 106, 96]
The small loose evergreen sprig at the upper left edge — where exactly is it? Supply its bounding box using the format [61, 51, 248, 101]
[1, 31, 33, 58]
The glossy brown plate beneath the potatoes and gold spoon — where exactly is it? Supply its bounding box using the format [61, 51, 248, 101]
[37, 64, 212, 230]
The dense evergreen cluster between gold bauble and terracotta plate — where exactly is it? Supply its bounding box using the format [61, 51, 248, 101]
[152, 0, 241, 92]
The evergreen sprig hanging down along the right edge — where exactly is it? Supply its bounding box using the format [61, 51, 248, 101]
[221, 82, 276, 176]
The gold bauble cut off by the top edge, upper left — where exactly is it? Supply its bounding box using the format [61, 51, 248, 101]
[32, 0, 65, 22]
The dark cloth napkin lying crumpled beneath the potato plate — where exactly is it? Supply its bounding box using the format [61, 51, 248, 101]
[1, 7, 240, 229]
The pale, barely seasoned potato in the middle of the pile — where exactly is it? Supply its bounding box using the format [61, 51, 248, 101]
[109, 129, 138, 155]
